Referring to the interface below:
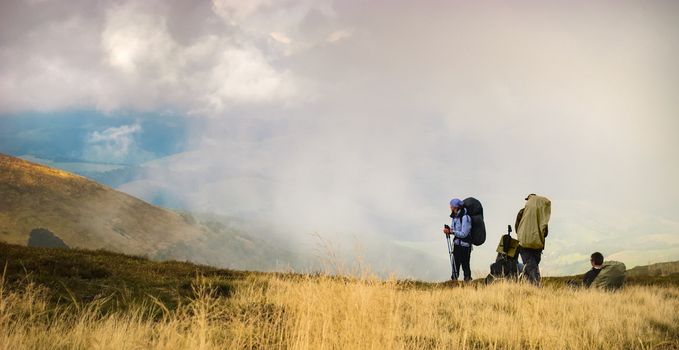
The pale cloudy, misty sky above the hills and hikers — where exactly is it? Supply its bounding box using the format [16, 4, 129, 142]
[0, 0, 679, 279]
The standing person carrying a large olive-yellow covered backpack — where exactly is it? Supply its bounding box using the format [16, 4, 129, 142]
[516, 193, 552, 286]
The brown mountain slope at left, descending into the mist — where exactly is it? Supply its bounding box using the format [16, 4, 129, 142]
[0, 153, 308, 271]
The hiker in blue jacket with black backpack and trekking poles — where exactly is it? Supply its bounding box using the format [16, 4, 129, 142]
[443, 198, 486, 282]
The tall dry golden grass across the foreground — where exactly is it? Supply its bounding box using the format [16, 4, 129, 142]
[0, 275, 679, 349]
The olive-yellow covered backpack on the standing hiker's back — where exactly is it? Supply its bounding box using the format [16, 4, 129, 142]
[516, 196, 552, 249]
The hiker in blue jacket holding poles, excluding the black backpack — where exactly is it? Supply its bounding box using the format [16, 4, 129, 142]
[443, 198, 472, 282]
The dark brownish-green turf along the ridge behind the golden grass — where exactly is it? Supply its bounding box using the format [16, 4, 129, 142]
[0, 242, 679, 308]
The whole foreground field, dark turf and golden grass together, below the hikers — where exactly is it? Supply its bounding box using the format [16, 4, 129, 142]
[0, 245, 679, 349]
